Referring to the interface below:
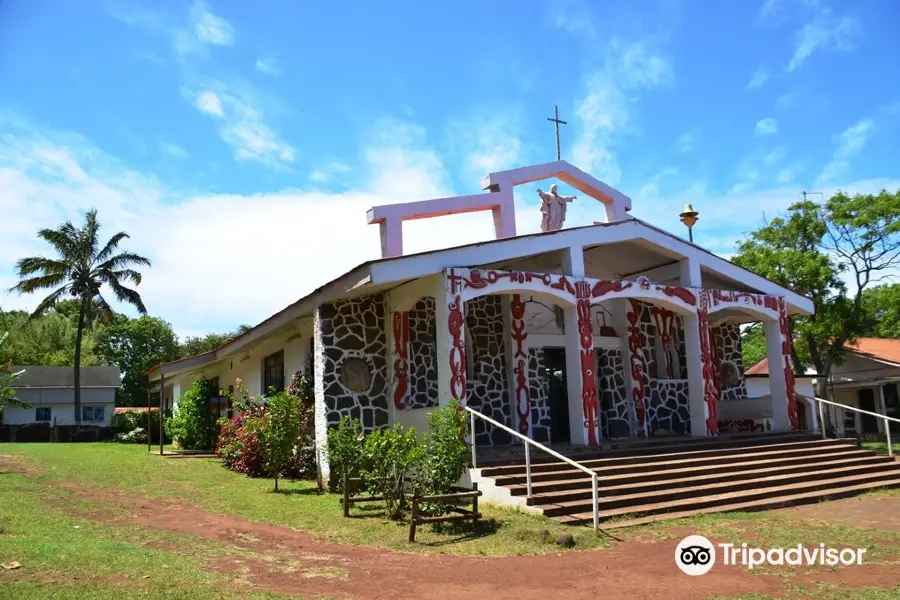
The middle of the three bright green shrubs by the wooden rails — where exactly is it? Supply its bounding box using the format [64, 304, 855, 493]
[362, 423, 422, 519]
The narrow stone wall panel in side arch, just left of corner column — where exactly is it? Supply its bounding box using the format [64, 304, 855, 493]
[404, 297, 438, 408]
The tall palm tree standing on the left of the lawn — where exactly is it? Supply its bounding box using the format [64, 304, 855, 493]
[9, 209, 150, 427]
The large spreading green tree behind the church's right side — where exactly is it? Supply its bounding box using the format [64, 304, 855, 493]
[733, 190, 900, 389]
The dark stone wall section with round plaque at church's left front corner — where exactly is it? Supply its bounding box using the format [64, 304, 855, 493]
[314, 294, 388, 430]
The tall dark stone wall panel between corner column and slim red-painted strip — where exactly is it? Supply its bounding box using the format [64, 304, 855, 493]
[466, 295, 513, 445]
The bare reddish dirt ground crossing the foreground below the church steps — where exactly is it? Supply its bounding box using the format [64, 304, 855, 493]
[51, 484, 900, 600]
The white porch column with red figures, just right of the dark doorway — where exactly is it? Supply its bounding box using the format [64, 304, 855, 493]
[564, 281, 600, 446]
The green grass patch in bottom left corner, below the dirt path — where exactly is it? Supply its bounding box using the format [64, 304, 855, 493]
[0, 458, 298, 600]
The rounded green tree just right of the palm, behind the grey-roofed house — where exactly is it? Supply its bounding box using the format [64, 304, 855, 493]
[96, 316, 179, 406]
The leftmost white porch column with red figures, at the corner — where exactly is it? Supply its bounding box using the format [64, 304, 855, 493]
[434, 274, 466, 406]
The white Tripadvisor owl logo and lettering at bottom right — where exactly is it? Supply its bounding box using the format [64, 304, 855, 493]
[675, 535, 868, 575]
